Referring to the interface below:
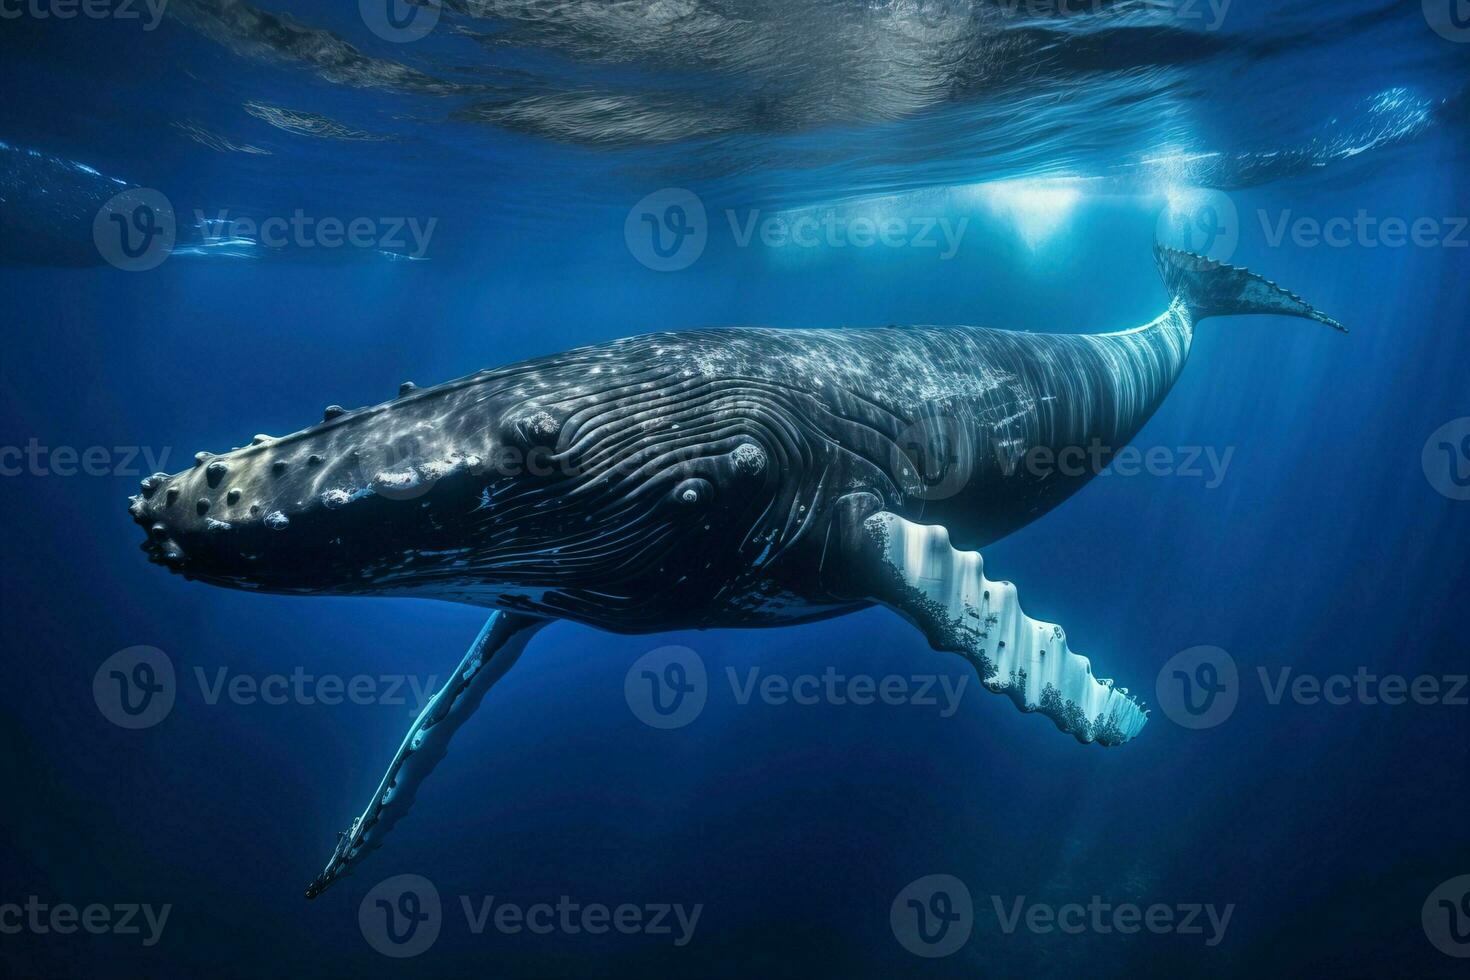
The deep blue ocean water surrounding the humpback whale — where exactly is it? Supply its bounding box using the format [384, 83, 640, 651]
[0, 0, 1470, 977]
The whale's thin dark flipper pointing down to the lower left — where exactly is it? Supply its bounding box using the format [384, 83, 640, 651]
[306, 611, 547, 898]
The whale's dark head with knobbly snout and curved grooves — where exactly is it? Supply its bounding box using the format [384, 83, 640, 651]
[129, 363, 778, 625]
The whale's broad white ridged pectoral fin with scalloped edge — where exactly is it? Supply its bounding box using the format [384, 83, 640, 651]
[863, 511, 1148, 745]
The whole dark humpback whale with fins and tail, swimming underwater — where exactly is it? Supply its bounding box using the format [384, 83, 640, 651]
[129, 248, 1345, 898]
